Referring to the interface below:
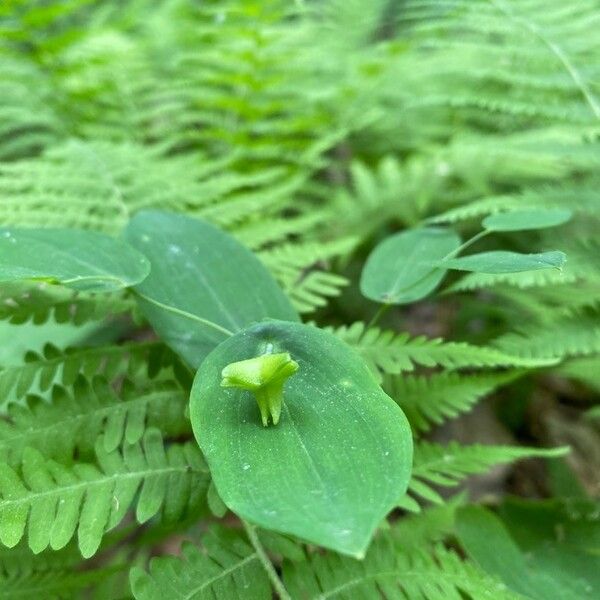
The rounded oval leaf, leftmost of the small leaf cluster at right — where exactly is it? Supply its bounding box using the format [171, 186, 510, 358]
[360, 227, 460, 304]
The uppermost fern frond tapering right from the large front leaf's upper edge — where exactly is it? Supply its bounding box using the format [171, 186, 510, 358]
[328, 322, 553, 376]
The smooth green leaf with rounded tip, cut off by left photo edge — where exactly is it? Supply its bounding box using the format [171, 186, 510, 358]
[0, 229, 150, 292]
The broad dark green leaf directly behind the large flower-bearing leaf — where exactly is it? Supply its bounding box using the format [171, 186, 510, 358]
[125, 211, 298, 367]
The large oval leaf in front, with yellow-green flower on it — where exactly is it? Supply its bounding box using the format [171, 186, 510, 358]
[190, 321, 412, 557]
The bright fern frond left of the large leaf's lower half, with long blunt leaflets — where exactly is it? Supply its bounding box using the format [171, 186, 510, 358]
[0, 429, 209, 558]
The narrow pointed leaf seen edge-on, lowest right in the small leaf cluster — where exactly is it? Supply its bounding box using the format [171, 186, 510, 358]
[439, 250, 567, 273]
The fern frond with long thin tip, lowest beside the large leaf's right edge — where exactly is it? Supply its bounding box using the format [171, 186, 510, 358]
[400, 441, 568, 512]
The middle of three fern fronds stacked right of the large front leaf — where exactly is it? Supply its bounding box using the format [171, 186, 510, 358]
[383, 371, 521, 433]
